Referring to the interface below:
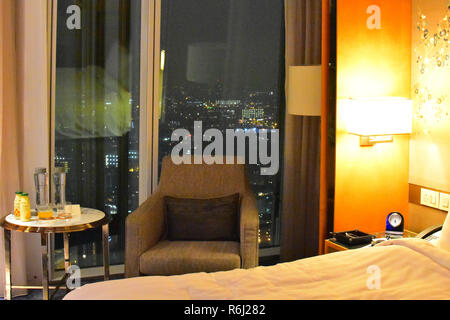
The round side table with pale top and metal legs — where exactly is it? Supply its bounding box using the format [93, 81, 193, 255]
[0, 208, 111, 300]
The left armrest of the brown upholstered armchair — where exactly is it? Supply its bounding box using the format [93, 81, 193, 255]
[125, 192, 164, 278]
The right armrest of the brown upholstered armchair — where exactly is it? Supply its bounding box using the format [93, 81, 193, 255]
[240, 191, 259, 269]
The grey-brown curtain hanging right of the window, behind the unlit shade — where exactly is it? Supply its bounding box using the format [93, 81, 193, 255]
[281, 0, 322, 261]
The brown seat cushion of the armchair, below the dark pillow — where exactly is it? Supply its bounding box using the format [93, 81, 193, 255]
[139, 241, 241, 276]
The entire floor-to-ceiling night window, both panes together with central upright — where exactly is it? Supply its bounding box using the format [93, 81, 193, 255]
[52, 0, 284, 269]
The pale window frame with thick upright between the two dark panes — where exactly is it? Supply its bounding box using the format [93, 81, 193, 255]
[47, 0, 280, 280]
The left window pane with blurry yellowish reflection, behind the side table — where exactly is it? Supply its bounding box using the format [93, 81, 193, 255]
[53, 0, 141, 268]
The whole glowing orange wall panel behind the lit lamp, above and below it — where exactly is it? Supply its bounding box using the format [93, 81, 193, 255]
[334, 0, 412, 232]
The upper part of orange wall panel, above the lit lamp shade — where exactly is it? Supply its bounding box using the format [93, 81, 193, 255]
[337, 0, 412, 97]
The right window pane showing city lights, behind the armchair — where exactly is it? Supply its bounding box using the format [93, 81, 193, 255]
[158, 0, 285, 247]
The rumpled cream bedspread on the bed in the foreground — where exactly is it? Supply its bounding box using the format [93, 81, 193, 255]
[65, 239, 450, 300]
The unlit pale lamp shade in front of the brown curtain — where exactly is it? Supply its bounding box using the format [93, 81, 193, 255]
[287, 65, 322, 116]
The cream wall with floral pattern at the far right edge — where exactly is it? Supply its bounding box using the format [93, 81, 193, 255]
[409, 0, 450, 192]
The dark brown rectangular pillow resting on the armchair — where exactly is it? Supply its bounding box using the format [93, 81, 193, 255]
[164, 193, 240, 241]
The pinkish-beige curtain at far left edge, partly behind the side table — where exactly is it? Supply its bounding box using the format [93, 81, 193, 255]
[0, 0, 26, 296]
